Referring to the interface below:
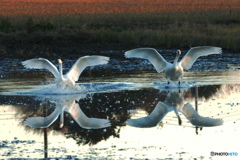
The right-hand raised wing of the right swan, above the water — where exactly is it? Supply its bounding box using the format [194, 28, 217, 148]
[179, 46, 222, 70]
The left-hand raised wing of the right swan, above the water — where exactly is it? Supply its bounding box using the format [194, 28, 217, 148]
[125, 48, 169, 72]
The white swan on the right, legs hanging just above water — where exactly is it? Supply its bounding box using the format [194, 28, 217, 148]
[125, 46, 222, 85]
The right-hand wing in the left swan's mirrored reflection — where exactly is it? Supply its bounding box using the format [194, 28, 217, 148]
[66, 103, 111, 129]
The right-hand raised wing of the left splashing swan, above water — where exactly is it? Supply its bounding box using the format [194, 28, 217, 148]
[66, 56, 109, 81]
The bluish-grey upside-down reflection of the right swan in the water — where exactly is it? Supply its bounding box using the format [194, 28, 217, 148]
[127, 92, 223, 128]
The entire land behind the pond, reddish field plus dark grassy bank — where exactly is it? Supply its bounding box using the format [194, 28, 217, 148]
[0, 0, 240, 58]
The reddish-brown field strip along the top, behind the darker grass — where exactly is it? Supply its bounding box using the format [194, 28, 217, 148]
[0, 0, 240, 16]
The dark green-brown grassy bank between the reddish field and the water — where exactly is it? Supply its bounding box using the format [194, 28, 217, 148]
[0, 2, 240, 57]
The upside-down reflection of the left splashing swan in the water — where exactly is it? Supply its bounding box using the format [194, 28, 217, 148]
[24, 96, 111, 129]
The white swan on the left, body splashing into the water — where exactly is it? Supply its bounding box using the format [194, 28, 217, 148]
[22, 56, 109, 86]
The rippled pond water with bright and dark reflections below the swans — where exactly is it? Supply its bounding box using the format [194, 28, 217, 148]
[0, 53, 240, 159]
